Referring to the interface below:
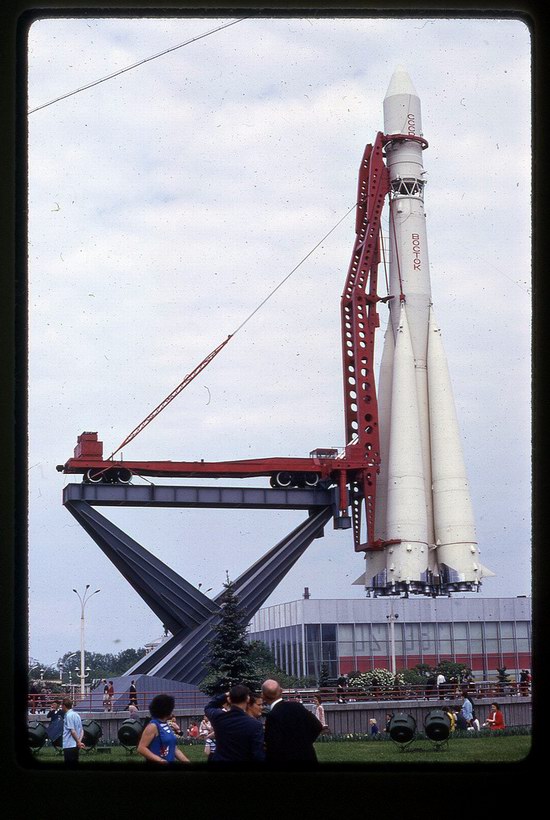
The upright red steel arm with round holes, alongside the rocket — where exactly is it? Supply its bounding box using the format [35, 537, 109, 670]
[341, 132, 390, 550]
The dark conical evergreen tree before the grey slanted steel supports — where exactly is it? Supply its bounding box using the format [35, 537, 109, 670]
[199, 576, 260, 695]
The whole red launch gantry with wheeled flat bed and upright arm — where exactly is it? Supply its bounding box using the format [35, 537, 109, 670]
[57, 132, 406, 551]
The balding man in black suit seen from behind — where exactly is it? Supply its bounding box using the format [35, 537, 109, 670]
[262, 680, 323, 766]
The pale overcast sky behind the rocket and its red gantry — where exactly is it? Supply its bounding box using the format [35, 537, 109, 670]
[24, 12, 531, 663]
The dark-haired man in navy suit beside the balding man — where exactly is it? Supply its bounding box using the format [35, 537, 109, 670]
[204, 684, 265, 763]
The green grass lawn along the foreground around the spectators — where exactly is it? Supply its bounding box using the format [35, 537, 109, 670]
[29, 735, 531, 768]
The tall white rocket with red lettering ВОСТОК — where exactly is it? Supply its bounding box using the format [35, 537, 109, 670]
[355, 68, 494, 594]
